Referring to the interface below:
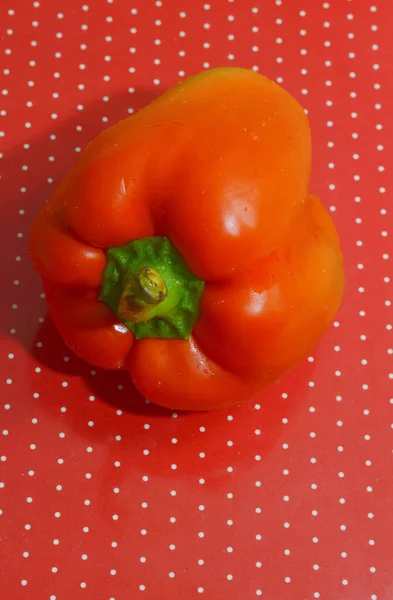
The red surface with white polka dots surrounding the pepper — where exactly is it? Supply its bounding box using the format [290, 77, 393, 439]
[0, 0, 393, 600]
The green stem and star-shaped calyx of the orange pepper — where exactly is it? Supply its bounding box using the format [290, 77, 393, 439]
[100, 237, 204, 340]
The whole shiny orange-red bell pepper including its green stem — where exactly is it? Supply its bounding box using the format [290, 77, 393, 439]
[30, 68, 344, 410]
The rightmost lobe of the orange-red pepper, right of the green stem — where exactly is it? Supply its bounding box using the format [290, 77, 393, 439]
[194, 197, 344, 383]
